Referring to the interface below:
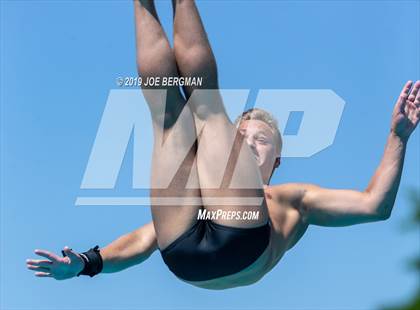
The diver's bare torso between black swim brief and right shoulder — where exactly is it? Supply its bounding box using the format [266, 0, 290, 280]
[181, 184, 308, 290]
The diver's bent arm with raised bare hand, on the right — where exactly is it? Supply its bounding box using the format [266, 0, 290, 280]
[278, 81, 420, 226]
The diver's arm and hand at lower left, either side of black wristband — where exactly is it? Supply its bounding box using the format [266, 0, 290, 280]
[26, 222, 157, 280]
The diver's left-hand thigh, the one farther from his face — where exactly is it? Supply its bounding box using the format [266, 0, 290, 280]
[150, 92, 202, 249]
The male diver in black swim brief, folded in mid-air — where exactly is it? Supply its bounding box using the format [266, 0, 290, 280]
[27, 0, 420, 289]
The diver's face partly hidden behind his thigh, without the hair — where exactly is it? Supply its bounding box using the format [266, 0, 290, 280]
[239, 120, 278, 184]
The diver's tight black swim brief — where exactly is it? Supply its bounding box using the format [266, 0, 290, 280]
[161, 220, 270, 281]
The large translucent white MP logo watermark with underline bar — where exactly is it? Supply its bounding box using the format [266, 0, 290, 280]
[75, 89, 345, 206]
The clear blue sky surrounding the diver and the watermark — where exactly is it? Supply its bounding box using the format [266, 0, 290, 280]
[1, 1, 420, 309]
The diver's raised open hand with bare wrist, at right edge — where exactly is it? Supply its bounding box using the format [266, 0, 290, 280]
[391, 81, 420, 141]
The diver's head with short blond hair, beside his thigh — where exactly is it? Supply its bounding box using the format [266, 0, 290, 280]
[235, 108, 283, 184]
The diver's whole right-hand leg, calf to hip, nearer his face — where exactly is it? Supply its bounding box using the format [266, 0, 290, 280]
[173, 0, 268, 227]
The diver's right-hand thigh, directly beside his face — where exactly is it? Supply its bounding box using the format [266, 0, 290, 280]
[197, 116, 268, 227]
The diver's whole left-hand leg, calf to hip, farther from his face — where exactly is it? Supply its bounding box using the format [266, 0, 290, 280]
[134, 0, 201, 249]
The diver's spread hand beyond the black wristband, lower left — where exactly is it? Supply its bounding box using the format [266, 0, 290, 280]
[26, 246, 84, 280]
